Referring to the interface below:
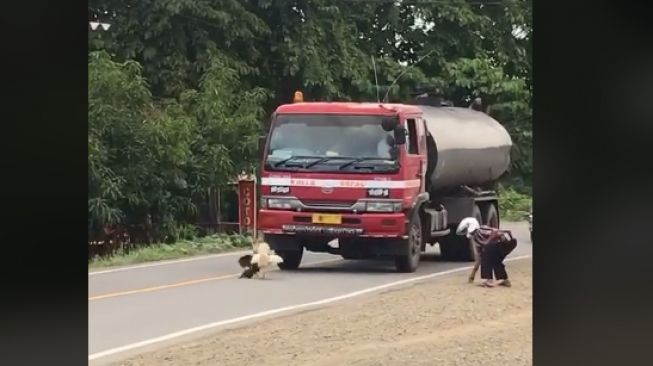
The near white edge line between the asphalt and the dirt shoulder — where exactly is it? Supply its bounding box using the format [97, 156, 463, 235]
[88, 255, 532, 361]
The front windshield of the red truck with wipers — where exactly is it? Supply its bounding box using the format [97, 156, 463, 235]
[266, 115, 397, 171]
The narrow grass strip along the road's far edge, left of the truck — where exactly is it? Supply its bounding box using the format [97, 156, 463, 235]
[88, 234, 252, 269]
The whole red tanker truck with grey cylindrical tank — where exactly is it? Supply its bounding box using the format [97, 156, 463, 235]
[257, 93, 512, 272]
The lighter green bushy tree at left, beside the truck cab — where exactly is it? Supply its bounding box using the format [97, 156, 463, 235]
[89, 52, 267, 240]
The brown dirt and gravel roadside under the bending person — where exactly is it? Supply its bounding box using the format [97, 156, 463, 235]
[114, 259, 533, 366]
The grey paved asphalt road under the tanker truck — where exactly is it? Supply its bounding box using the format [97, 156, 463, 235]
[89, 223, 532, 364]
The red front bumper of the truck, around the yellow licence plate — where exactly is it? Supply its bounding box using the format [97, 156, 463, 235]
[258, 210, 406, 238]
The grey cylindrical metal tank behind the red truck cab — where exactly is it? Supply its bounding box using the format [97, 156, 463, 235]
[419, 105, 512, 191]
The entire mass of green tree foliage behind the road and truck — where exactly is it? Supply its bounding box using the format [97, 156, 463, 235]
[88, 0, 532, 243]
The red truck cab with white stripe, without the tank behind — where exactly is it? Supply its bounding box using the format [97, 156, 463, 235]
[258, 102, 427, 272]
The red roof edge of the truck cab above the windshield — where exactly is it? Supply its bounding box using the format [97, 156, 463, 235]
[276, 102, 422, 115]
